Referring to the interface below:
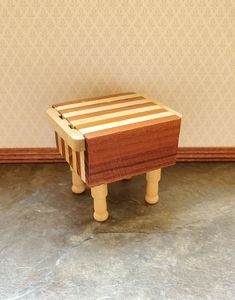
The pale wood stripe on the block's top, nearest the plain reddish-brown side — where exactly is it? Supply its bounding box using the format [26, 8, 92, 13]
[79, 111, 174, 134]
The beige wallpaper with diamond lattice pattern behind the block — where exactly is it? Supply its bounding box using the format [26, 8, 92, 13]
[0, 0, 235, 147]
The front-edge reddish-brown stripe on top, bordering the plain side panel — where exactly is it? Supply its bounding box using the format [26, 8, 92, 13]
[84, 116, 180, 139]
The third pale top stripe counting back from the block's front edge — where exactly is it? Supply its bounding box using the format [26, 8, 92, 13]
[62, 99, 152, 119]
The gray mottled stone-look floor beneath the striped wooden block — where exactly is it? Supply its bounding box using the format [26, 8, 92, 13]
[0, 163, 235, 300]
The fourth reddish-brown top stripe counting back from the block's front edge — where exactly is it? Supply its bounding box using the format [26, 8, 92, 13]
[58, 97, 145, 115]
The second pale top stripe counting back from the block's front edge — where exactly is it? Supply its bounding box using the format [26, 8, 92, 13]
[70, 104, 162, 126]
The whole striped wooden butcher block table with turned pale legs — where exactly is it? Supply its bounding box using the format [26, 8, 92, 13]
[47, 93, 181, 221]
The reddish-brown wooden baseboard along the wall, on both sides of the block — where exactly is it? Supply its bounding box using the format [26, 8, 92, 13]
[0, 147, 235, 163]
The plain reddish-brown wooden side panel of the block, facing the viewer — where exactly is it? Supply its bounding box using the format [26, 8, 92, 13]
[85, 118, 180, 186]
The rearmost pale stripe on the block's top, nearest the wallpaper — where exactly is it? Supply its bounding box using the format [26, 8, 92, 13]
[56, 94, 140, 111]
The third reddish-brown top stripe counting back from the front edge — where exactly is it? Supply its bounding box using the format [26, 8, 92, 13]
[66, 102, 156, 121]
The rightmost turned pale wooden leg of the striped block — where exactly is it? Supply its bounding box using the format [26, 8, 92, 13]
[145, 169, 161, 204]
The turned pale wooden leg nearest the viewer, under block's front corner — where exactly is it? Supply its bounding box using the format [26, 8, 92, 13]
[91, 184, 109, 222]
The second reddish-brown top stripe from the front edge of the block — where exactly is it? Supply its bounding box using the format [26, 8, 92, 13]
[76, 108, 167, 129]
